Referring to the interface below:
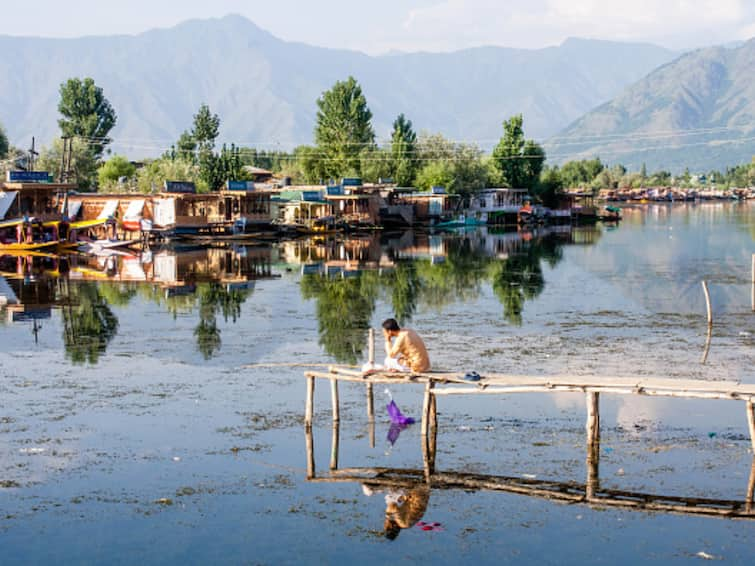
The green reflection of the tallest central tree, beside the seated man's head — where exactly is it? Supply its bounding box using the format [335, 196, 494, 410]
[301, 272, 380, 364]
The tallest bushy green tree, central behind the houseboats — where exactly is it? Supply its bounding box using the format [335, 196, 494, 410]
[315, 77, 375, 177]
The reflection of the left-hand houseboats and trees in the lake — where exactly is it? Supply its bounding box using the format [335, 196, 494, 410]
[0, 248, 273, 364]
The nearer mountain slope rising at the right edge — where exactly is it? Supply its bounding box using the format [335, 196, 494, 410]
[547, 39, 755, 172]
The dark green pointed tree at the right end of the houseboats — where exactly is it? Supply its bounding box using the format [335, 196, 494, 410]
[493, 114, 545, 189]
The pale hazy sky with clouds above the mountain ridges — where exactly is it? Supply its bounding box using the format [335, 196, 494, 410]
[0, 0, 755, 54]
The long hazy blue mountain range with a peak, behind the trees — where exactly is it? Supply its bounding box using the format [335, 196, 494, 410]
[0, 16, 674, 157]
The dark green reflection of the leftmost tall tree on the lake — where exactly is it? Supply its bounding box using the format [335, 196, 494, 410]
[61, 280, 118, 364]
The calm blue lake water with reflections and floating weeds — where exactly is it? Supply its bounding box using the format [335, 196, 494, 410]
[0, 203, 755, 564]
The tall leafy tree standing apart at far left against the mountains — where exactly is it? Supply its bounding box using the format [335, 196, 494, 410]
[58, 77, 117, 159]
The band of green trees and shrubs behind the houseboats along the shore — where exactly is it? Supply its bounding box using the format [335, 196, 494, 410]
[0, 77, 755, 206]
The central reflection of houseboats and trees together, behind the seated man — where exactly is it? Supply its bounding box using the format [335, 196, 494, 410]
[296, 226, 600, 364]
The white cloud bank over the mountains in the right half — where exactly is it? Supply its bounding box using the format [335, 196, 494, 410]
[396, 0, 755, 49]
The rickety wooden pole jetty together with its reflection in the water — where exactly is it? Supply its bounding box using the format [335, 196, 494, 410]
[304, 344, 755, 519]
